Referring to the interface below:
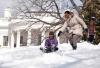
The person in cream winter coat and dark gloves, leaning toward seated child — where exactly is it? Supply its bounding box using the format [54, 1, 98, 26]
[58, 11, 87, 50]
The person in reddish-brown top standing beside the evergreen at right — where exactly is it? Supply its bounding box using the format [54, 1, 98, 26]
[88, 18, 96, 43]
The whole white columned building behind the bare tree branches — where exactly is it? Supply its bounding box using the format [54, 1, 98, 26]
[0, 8, 56, 48]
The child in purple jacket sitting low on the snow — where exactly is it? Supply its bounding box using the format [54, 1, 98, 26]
[40, 31, 58, 53]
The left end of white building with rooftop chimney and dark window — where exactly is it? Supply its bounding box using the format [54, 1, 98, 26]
[0, 8, 11, 47]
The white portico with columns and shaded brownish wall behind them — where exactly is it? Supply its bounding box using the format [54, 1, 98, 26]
[9, 20, 42, 48]
